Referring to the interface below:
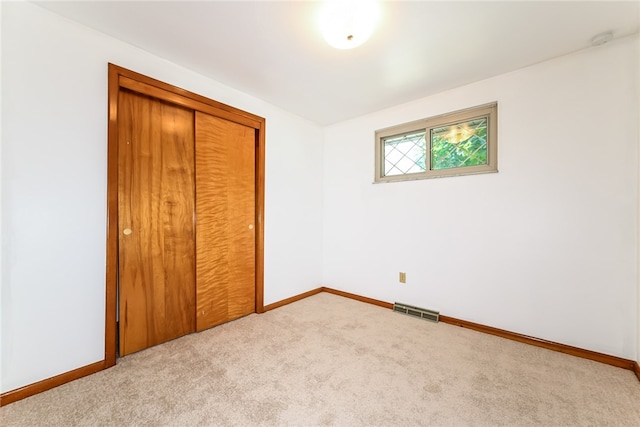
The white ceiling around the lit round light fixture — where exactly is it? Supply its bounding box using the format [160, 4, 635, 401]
[37, 0, 640, 125]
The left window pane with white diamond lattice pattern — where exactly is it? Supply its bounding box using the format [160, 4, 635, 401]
[382, 131, 427, 176]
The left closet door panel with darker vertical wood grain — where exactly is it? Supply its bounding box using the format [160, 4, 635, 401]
[118, 91, 195, 355]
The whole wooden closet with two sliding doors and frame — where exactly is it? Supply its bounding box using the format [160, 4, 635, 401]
[105, 64, 264, 358]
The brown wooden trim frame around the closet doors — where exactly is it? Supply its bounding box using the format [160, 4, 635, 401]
[105, 63, 265, 368]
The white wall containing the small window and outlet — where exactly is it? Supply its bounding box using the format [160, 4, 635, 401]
[323, 37, 640, 359]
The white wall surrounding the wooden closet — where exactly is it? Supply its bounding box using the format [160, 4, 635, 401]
[1, 2, 323, 392]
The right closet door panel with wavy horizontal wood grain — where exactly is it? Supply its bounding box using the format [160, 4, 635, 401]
[196, 112, 256, 331]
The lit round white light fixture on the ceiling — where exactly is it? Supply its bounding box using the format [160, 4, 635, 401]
[320, 0, 380, 49]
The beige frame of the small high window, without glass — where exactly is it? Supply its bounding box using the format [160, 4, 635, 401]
[374, 102, 498, 183]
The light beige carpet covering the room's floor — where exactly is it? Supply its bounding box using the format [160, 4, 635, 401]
[0, 293, 640, 427]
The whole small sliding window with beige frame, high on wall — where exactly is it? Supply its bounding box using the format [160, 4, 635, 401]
[375, 103, 498, 182]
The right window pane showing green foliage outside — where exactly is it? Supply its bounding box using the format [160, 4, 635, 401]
[431, 117, 488, 170]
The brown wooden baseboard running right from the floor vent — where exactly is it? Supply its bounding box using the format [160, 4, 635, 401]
[440, 316, 635, 371]
